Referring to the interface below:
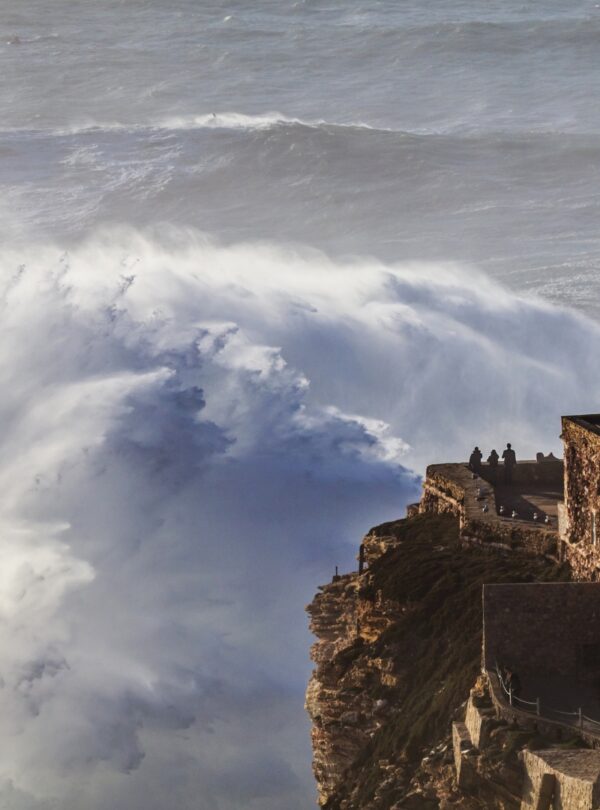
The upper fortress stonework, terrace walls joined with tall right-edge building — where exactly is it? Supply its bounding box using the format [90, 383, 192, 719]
[418, 414, 600, 582]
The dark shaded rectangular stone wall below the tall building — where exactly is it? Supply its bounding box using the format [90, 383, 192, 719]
[483, 582, 600, 680]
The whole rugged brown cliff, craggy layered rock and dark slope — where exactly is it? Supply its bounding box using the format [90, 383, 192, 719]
[306, 514, 566, 810]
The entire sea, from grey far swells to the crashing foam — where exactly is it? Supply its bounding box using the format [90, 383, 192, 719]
[0, 0, 600, 810]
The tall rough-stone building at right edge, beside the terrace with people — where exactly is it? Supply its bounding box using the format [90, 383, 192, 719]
[559, 414, 600, 580]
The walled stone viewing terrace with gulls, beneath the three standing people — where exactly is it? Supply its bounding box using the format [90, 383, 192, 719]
[418, 457, 564, 556]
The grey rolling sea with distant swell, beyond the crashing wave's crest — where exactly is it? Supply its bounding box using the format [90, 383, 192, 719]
[0, 0, 600, 313]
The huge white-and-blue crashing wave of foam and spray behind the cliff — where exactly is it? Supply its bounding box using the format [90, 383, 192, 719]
[0, 231, 600, 810]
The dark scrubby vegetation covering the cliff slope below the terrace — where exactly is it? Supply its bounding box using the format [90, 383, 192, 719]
[316, 514, 569, 810]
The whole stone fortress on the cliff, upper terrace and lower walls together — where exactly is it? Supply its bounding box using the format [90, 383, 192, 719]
[432, 415, 600, 810]
